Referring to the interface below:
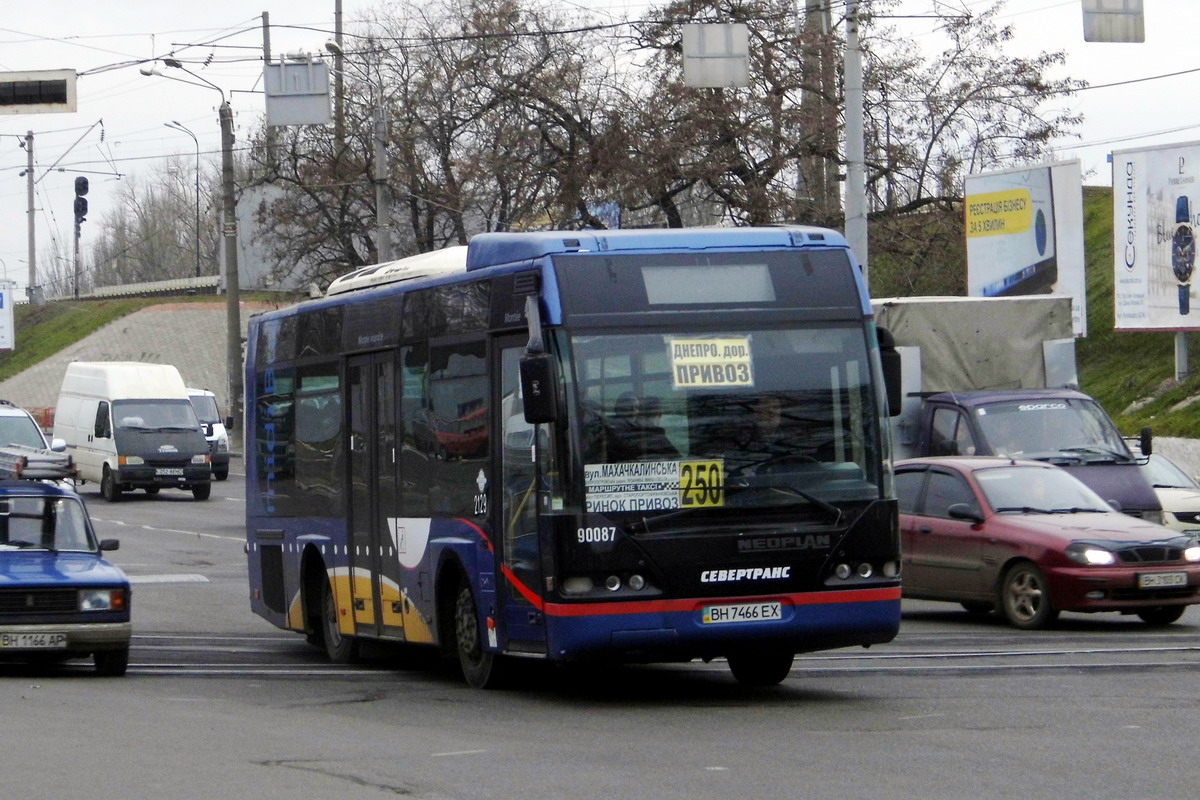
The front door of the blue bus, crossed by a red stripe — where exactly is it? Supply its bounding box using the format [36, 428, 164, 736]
[492, 336, 546, 652]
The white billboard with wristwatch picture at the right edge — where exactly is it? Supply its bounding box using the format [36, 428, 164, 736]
[1112, 142, 1200, 331]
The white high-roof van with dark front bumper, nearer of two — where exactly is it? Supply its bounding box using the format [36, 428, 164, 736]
[54, 361, 212, 503]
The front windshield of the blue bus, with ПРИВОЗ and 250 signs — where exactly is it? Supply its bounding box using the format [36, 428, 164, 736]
[571, 325, 883, 518]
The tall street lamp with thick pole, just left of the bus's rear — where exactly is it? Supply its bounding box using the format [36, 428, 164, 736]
[139, 59, 242, 425]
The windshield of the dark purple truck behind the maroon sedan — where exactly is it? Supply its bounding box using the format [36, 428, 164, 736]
[976, 398, 1133, 461]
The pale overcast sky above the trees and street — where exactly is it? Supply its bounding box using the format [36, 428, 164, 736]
[0, 0, 1200, 297]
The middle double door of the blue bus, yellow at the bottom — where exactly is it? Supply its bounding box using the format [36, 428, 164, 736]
[347, 353, 403, 638]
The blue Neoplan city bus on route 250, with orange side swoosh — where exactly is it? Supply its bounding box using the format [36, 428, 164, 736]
[245, 227, 900, 687]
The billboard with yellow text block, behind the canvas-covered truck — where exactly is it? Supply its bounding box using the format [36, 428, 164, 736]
[962, 161, 1087, 336]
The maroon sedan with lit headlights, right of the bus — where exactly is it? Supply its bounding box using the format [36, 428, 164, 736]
[895, 457, 1200, 630]
